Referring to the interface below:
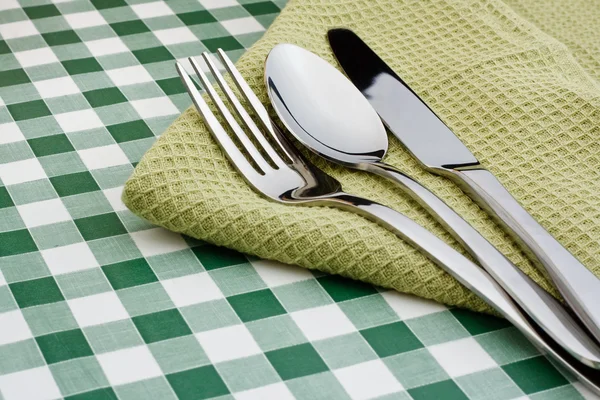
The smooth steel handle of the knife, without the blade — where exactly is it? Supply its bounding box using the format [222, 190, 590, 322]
[447, 169, 600, 340]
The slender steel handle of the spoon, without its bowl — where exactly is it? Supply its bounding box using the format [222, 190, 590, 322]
[367, 163, 600, 369]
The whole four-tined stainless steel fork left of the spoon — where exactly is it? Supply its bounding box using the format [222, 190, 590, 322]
[176, 49, 600, 395]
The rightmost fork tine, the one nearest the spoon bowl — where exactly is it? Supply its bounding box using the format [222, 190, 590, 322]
[217, 49, 298, 162]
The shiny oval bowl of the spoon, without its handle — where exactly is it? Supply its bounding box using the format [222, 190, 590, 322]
[265, 44, 388, 165]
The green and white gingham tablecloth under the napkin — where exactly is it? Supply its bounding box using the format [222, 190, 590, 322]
[0, 0, 592, 400]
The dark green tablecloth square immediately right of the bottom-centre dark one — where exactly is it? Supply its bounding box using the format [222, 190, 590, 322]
[360, 321, 423, 357]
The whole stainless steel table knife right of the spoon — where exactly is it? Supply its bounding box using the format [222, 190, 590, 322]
[327, 29, 600, 340]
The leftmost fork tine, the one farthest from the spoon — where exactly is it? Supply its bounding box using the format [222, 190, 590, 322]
[176, 62, 260, 181]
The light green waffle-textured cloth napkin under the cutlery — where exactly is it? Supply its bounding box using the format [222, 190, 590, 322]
[123, 0, 600, 311]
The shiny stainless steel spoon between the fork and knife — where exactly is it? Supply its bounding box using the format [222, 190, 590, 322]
[265, 44, 600, 369]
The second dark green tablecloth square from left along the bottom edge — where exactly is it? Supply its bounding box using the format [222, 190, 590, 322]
[167, 365, 229, 400]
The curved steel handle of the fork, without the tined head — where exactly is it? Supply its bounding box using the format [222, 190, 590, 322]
[323, 193, 600, 395]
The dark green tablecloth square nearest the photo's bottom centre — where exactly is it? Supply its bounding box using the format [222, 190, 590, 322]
[265, 343, 328, 380]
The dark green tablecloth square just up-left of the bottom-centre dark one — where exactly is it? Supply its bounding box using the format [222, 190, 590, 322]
[227, 289, 285, 322]
